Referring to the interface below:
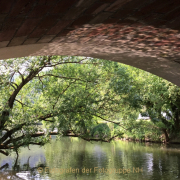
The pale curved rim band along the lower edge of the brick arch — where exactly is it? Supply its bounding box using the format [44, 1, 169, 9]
[0, 29, 180, 86]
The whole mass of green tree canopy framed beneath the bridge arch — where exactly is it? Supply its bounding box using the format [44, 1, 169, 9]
[0, 56, 180, 155]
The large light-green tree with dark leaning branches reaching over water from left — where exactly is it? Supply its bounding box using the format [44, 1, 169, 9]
[0, 56, 131, 155]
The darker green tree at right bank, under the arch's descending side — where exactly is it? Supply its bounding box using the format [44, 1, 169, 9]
[115, 64, 180, 141]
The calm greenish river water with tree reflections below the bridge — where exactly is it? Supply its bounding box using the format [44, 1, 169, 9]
[0, 137, 180, 180]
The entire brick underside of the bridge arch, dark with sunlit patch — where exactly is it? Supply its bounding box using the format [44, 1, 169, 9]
[0, 0, 180, 86]
